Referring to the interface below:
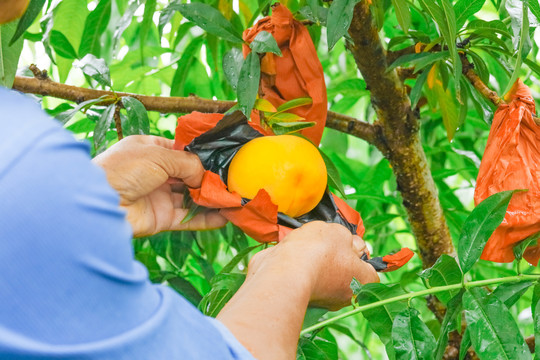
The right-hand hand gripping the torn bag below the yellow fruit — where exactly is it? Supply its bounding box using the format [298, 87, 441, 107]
[248, 221, 379, 310]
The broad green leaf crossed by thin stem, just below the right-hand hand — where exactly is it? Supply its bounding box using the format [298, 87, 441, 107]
[356, 283, 407, 358]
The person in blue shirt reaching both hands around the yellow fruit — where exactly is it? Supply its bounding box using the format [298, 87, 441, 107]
[0, 5, 378, 359]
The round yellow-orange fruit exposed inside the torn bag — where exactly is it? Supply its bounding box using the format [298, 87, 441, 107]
[228, 135, 327, 217]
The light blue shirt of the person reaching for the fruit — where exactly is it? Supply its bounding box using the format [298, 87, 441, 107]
[0, 88, 253, 360]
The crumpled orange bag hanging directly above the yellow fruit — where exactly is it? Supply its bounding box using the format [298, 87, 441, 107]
[243, 3, 328, 145]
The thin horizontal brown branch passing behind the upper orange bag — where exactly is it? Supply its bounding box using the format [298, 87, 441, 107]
[13, 73, 381, 147]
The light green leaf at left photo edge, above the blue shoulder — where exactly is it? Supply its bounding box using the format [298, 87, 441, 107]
[0, 21, 23, 89]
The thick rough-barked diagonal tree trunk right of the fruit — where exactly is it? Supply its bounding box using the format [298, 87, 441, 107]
[348, 1, 454, 267]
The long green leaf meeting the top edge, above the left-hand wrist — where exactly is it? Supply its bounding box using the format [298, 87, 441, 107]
[79, 0, 111, 57]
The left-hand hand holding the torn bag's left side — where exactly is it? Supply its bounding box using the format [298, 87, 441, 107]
[93, 135, 227, 237]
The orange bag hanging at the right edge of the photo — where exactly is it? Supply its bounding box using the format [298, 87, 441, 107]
[474, 80, 540, 266]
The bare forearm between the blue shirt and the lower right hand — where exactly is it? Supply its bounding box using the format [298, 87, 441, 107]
[217, 250, 312, 360]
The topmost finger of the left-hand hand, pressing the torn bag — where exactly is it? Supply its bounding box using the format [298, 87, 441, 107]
[154, 147, 204, 188]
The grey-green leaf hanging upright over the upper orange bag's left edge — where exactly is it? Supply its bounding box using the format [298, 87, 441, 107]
[236, 52, 261, 119]
